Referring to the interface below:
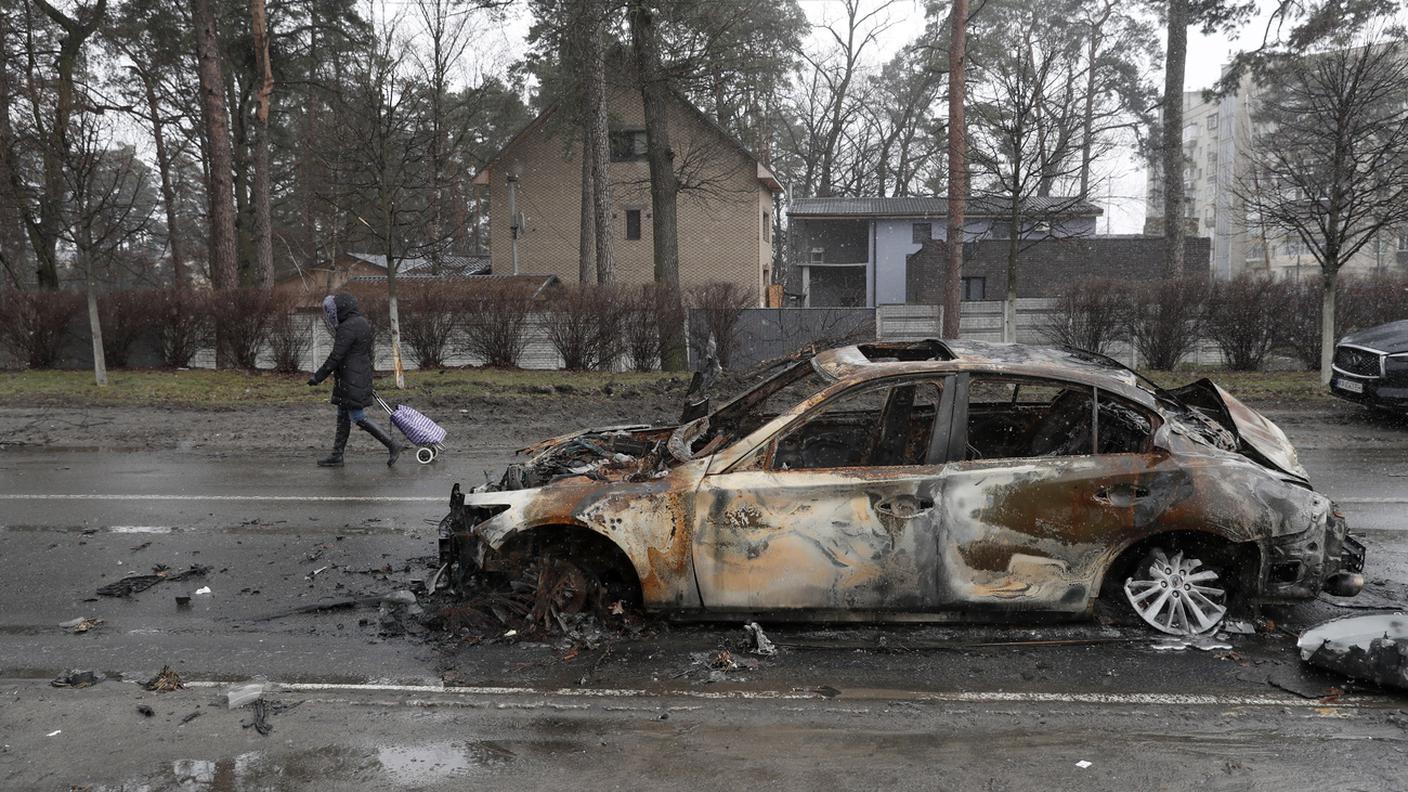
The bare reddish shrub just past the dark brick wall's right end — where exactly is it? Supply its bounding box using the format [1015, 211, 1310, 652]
[1204, 273, 1291, 371]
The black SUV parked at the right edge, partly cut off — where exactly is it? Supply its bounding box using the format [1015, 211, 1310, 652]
[1329, 320, 1408, 407]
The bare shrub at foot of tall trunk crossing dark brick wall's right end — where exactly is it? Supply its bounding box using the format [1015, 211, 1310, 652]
[1124, 278, 1208, 371]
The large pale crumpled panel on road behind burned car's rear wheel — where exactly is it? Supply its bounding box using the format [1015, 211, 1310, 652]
[1295, 613, 1408, 689]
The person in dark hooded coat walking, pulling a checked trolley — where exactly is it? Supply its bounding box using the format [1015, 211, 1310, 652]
[308, 295, 401, 468]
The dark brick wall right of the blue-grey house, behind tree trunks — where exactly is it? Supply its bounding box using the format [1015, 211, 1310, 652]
[905, 237, 1211, 304]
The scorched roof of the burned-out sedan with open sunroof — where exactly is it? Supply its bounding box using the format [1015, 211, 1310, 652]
[811, 338, 1155, 406]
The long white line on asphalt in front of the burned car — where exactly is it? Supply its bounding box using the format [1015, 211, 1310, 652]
[184, 681, 1373, 709]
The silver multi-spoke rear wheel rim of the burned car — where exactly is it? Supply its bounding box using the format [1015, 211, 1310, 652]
[1125, 548, 1228, 636]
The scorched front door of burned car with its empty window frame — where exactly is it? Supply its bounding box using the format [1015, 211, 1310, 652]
[693, 371, 956, 617]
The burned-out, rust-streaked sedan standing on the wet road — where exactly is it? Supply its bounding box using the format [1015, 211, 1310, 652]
[441, 341, 1364, 634]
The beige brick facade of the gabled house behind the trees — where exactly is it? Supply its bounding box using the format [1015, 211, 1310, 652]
[474, 89, 781, 304]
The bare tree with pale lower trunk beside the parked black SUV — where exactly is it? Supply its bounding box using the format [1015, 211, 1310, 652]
[1239, 37, 1408, 382]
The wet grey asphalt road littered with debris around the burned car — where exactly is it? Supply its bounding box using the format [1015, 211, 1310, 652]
[0, 408, 1408, 789]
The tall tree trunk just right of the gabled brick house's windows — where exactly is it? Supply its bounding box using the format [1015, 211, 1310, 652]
[631, 0, 689, 371]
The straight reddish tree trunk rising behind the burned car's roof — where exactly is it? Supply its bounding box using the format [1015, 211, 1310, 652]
[943, 0, 969, 338]
